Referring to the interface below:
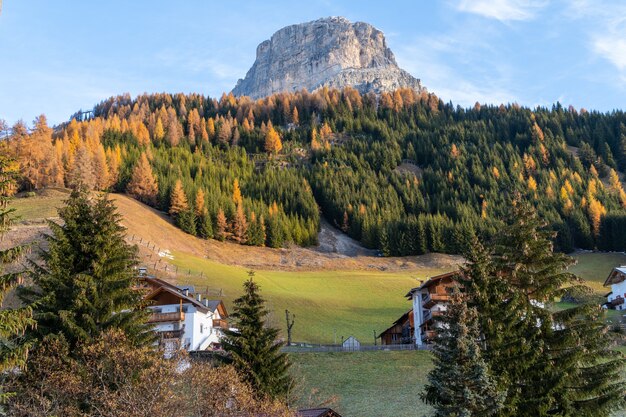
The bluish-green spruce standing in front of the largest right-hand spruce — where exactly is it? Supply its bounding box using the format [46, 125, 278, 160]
[421, 293, 505, 417]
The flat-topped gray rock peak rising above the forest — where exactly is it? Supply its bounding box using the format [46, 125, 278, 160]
[232, 17, 422, 99]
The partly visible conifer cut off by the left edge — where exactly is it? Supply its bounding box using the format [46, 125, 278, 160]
[0, 155, 35, 402]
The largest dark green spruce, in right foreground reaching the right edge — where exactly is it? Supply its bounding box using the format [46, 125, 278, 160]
[463, 200, 625, 417]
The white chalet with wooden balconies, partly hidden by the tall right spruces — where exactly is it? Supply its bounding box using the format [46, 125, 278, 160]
[406, 271, 459, 346]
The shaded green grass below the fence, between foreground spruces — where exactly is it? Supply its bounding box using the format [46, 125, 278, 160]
[291, 351, 432, 417]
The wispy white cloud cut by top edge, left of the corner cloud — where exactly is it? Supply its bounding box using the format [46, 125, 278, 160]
[456, 0, 546, 22]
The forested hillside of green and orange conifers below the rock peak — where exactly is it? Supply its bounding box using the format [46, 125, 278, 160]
[2, 88, 626, 255]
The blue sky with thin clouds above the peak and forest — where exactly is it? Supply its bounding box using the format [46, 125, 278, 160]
[0, 0, 626, 123]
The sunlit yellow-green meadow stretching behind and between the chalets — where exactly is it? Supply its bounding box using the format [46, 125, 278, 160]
[171, 252, 444, 344]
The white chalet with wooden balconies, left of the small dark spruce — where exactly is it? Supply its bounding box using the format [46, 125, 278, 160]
[139, 276, 228, 352]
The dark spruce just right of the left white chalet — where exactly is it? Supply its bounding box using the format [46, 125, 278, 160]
[222, 271, 292, 398]
